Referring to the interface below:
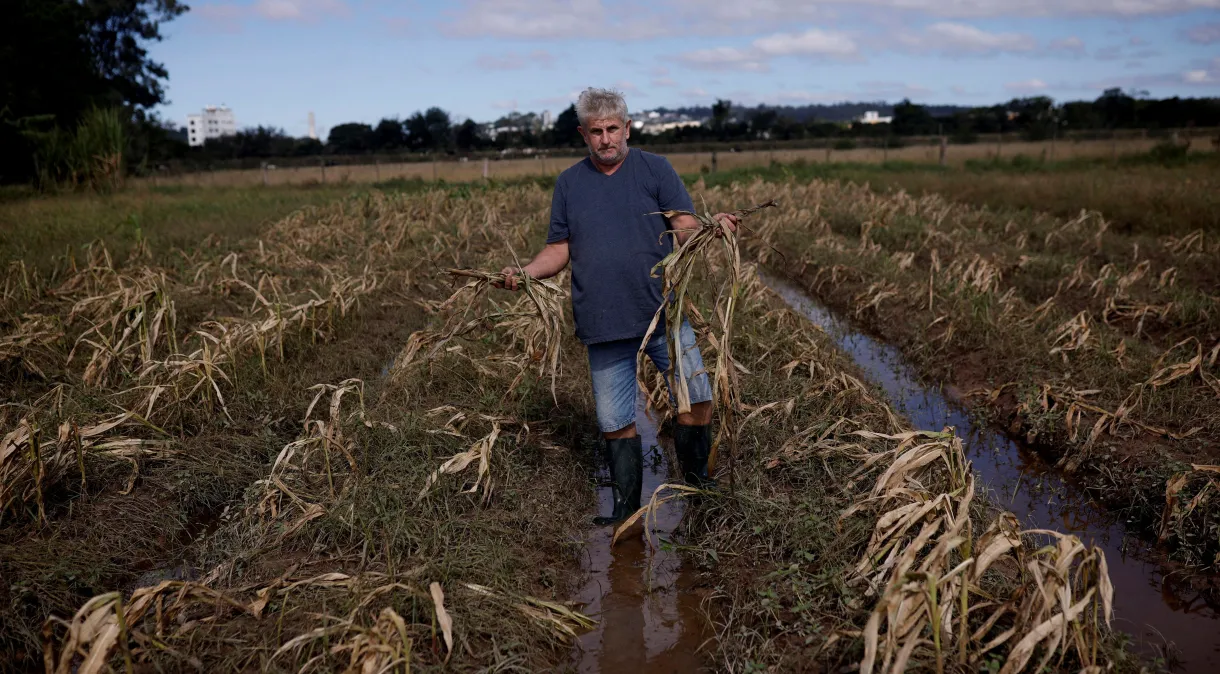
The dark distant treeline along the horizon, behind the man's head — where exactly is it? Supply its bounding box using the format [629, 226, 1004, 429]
[183, 89, 1220, 164]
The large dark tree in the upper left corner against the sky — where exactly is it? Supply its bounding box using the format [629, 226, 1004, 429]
[0, 0, 187, 182]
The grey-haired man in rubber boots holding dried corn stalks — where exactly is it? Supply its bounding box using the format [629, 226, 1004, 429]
[504, 88, 737, 525]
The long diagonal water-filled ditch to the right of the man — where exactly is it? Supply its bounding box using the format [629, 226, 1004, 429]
[764, 271, 1220, 673]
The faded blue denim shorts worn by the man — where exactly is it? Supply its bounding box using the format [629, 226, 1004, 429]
[588, 321, 711, 433]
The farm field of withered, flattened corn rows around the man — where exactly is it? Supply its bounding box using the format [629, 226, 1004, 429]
[0, 158, 1205, 672]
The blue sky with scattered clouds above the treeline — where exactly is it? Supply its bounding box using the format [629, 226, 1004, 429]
[149, 0, 1220, 138]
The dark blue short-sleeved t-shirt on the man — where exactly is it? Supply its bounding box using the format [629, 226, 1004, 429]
[547, 148, 694, 344]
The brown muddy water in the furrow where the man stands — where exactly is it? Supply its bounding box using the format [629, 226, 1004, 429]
[572, 398, 709, 674]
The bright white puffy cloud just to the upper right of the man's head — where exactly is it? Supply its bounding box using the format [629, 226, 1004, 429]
[678, 28, 858, 72]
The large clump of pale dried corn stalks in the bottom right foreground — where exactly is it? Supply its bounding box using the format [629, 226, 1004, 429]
[843, 431, 1114, 674]
